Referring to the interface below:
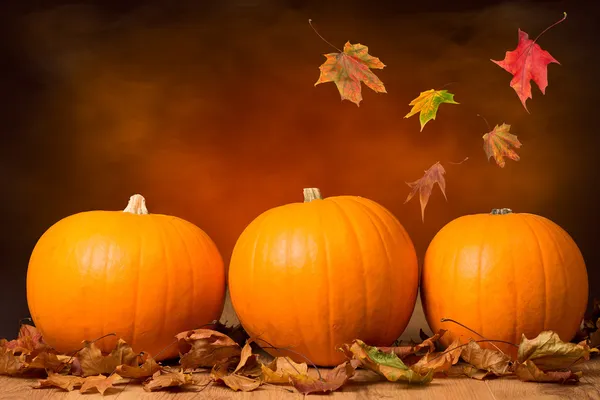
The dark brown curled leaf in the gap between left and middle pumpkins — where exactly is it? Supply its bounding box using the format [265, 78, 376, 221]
[176, 329, 241, 370]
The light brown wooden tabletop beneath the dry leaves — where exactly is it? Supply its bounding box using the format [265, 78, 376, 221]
[0, 357, 600, 400]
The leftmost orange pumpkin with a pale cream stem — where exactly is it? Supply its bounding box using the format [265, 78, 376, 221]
[27, 195, 226, 360]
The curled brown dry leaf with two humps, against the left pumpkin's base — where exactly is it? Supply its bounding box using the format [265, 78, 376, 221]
[72, 339, 138, 377]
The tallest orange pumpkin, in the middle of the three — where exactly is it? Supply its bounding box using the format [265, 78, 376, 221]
[229, 188, 418, 366]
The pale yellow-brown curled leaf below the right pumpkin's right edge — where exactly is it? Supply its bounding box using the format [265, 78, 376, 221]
[517, 331, 590, 371]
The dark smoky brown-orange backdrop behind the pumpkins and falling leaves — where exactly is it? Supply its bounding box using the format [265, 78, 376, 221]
[0, 0, 600, 337]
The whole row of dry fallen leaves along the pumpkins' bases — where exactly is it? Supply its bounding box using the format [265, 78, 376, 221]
[0, 301, 600, 394]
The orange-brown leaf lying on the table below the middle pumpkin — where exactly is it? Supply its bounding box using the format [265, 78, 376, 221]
[290, 360, 360, 394]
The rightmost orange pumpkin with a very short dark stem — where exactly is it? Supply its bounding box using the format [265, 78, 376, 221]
[421, 209, 588, 358]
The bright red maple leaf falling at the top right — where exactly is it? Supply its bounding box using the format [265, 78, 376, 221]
[491, 13, 567, 112]
